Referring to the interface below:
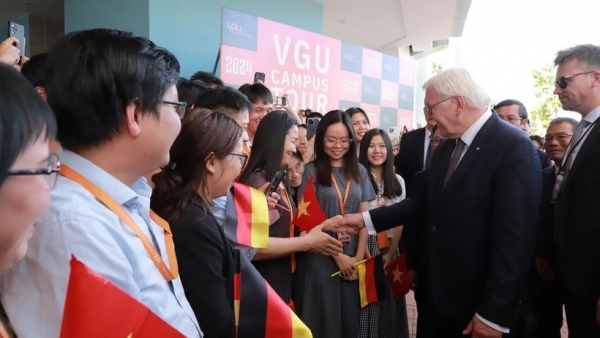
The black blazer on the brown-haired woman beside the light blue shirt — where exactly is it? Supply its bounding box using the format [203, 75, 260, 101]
[171, 205, 235, 338]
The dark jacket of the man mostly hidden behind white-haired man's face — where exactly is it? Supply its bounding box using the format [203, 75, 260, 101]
[394, 128, 425, 196]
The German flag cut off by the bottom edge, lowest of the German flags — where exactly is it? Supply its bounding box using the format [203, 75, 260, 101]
[233, 250, 312, 338]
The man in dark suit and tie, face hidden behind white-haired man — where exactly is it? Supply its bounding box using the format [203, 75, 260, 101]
[394, 103, 435, 196]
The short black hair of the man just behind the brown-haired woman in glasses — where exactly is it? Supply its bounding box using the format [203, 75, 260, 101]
[194, 86, 254, 117]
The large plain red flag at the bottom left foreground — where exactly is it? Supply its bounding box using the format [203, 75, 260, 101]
[60, 255, 184, 338]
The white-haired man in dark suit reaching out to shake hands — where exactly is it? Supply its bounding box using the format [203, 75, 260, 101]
[338, 69, 542, 338]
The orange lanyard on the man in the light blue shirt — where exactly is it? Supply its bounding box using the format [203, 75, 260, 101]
[60, 163, 179, 281]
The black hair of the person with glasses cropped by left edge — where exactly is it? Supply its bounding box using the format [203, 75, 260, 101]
[0, 64, 56, 185]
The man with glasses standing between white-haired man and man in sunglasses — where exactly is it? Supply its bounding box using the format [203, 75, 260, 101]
[535, 117, 577, 338]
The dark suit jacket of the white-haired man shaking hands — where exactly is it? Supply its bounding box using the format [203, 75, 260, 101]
[370, 114, 542, 327]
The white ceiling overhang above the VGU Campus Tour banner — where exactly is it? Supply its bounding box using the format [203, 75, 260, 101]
[322, 0, 471, 56]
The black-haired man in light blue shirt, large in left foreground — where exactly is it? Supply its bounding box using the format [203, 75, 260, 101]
[0, 29, 202, 337]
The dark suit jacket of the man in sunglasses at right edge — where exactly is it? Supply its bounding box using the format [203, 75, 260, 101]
[554, 123, 600, 302]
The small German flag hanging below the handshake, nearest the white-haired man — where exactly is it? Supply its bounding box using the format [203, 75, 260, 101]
[356, 255, 387, 307]
